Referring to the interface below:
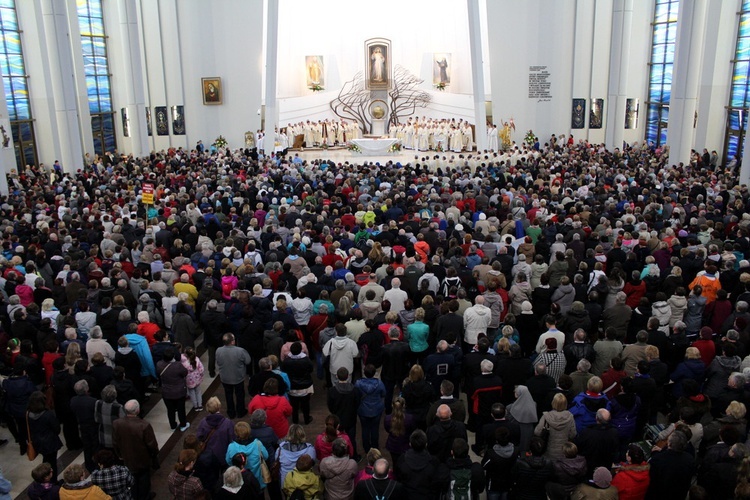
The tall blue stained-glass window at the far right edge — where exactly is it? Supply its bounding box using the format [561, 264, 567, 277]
[723, 0, 750, 163]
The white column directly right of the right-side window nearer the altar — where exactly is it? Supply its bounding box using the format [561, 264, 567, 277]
[667, 0, 706, 165]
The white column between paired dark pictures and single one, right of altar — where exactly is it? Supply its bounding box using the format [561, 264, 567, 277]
[605, 0, 633, 151]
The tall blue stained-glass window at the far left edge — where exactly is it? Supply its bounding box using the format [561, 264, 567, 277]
[0, 0, 39, 170]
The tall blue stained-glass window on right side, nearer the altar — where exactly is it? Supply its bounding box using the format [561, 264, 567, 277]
[646, 0, 680, 146]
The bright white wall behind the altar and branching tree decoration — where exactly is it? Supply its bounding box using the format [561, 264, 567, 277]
[277, 0, 476, 126]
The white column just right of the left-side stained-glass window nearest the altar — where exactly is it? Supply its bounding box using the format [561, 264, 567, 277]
[104, 0, 150, 156]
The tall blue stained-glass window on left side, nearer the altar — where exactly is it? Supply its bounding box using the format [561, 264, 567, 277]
[77, 0, 117, 154]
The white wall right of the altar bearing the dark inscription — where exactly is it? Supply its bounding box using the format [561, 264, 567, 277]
[487, 0, 653, 147]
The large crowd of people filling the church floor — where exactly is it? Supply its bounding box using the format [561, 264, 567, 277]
[0, 136, 750, 500]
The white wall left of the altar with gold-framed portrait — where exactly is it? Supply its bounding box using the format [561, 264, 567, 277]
[131, 0, 263, 149]
